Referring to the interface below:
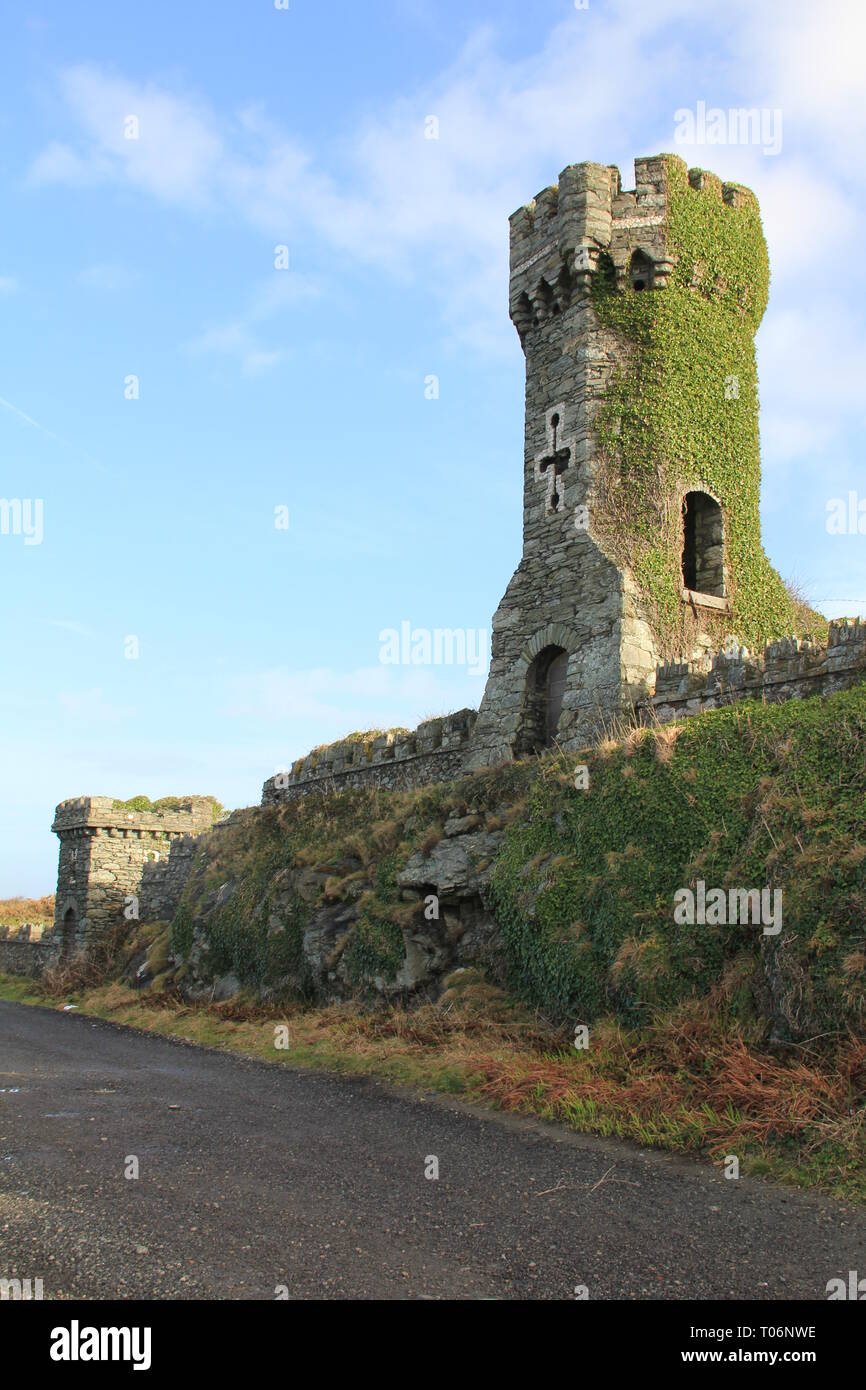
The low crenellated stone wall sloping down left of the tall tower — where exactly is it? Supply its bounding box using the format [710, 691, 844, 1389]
[261, 709, 477, 806]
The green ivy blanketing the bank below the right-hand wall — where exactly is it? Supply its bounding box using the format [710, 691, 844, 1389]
[489, 685, 866, 1027]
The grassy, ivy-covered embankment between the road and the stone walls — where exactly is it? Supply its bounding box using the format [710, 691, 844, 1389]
[3, 685, 866, 1198]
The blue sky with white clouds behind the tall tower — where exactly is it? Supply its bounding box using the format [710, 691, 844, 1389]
[0, 0, 866, 897]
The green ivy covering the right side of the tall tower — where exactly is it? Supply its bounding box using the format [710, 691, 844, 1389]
[592, 156, 827, 656]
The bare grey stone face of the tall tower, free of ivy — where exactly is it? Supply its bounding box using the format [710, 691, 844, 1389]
[471, 157, 692, 767]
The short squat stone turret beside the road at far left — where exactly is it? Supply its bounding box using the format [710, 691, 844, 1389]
[51, 796, 217, 956]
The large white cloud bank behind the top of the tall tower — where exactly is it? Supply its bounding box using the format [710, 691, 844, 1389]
[25, 0, 866, 386]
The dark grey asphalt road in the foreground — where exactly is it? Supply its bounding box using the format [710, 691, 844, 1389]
[0, 1002, 866, 1300]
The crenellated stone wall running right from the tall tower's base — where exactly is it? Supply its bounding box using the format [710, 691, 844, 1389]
[638, 619, 866, 723]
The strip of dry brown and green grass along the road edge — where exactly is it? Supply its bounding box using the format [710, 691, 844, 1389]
[5, 967, 866, 1200]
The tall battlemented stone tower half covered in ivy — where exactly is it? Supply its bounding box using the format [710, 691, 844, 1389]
[471, 156, 794, 767]
